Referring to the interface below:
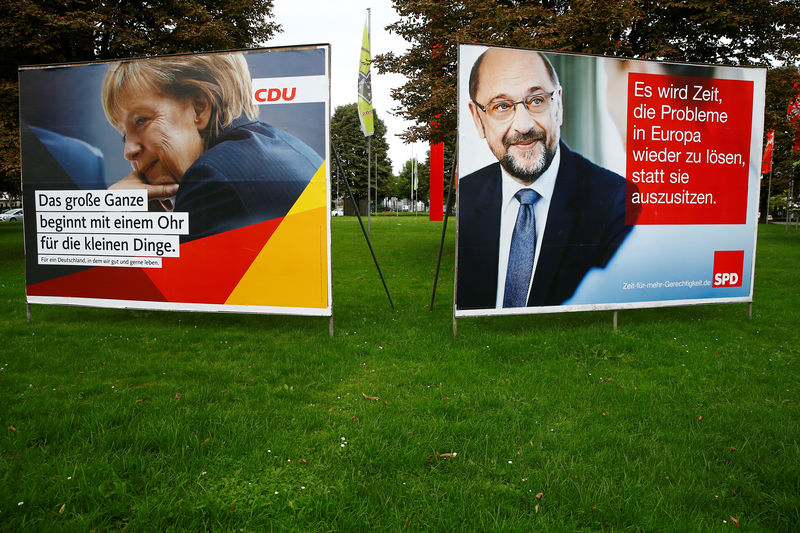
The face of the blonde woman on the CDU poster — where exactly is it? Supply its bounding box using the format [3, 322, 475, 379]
[119, 89, 210, 184]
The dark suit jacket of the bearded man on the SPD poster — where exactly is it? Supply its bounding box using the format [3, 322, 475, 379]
[456, 142, 632, 310]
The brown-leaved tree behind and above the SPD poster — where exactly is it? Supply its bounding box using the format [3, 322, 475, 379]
[375, 0, 800, 144]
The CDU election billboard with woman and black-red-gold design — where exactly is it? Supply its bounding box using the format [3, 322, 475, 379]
[19, 45, 331, 316]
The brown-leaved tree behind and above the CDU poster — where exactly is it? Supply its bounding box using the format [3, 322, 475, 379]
[0, 0, 280, 197]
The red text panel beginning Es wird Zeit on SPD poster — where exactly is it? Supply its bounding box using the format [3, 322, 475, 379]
[626, 73, 753, 225]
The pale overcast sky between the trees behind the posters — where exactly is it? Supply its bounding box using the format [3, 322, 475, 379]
[266, 0, 428, 173]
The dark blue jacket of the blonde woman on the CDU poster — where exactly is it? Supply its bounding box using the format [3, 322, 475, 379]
[175, 118, 322, 240]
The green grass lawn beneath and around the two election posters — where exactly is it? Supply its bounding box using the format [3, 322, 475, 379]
[0, 216, 800, 531]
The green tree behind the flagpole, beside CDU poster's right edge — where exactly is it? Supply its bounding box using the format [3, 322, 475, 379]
[331, 103, 394, 199]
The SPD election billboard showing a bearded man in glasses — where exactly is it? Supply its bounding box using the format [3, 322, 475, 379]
[455, 45, 766, 317]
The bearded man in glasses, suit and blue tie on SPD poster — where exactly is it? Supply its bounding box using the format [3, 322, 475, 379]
[456, 48, 632, 310]
